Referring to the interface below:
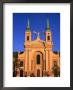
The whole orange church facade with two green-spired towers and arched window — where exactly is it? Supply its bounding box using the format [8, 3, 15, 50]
[16, 20, 60, 77]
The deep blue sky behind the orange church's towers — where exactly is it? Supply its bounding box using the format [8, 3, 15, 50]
[13, 13, 60, 51]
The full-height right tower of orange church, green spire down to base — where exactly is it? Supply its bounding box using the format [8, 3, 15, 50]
[45, 18, 53, 73]
